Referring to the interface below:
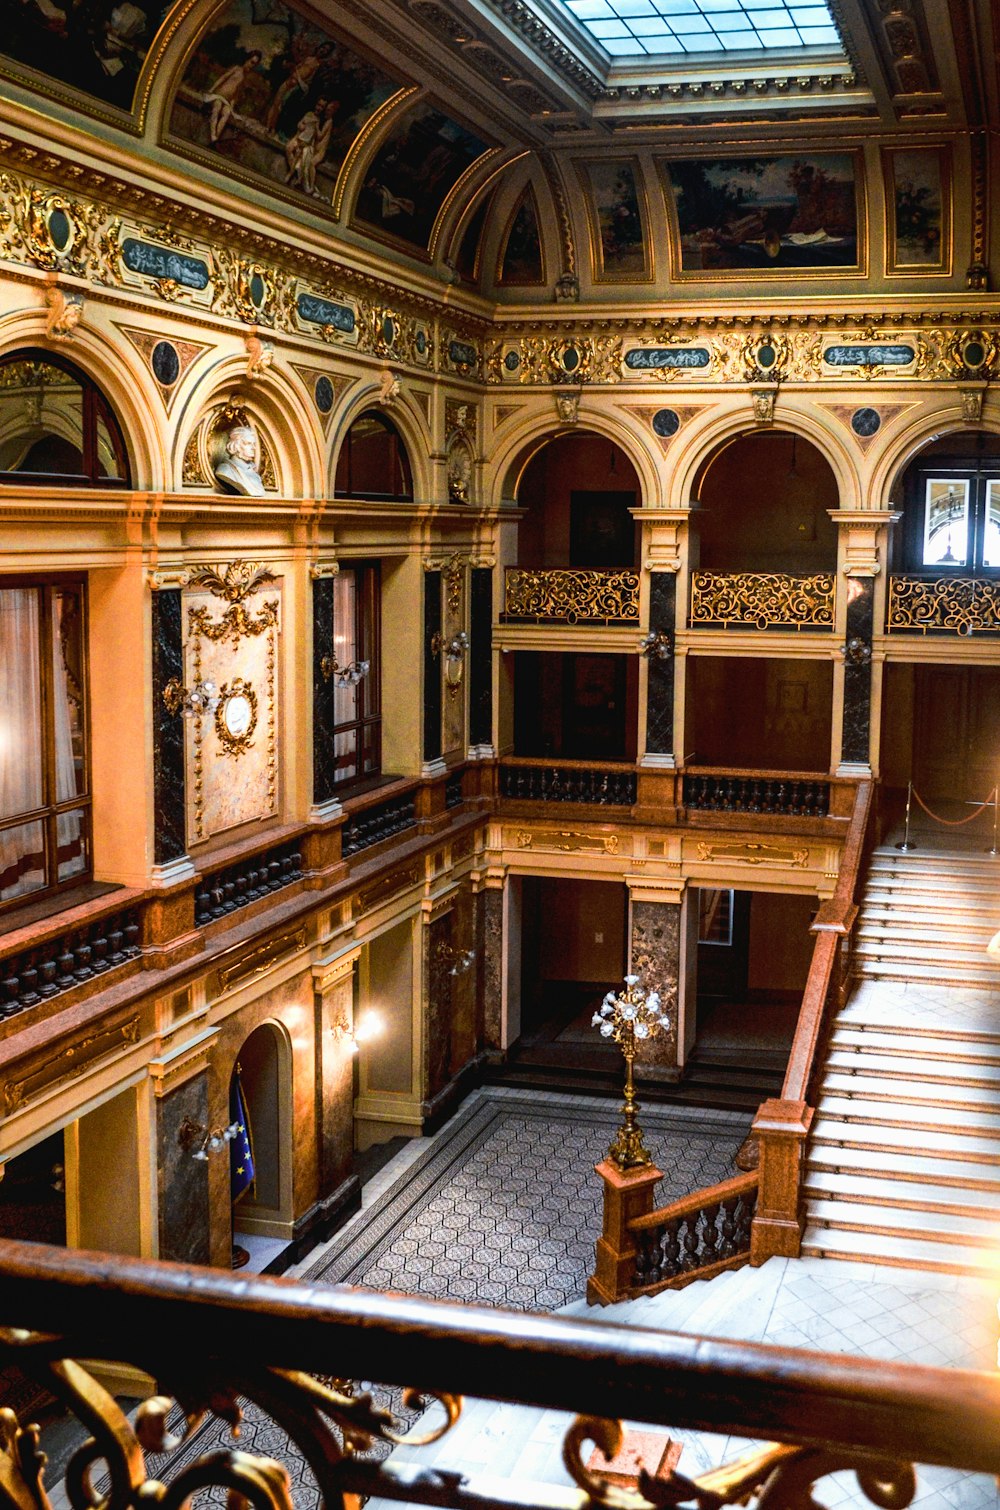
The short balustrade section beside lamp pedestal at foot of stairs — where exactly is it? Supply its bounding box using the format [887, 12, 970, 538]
[628, 1173, 757, 1294]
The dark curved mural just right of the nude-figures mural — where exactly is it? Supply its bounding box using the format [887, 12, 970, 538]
[355, 104, 488, 249]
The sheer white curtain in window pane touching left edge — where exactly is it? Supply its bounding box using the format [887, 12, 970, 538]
[0, 587, 45, 901]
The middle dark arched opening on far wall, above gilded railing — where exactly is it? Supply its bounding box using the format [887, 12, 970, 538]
[692, 430, 838, 577]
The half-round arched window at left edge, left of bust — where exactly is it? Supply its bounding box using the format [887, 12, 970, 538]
[0, 347, 130, 488]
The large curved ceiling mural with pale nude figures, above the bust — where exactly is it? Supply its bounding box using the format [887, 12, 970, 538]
[171, 0, 399, 204]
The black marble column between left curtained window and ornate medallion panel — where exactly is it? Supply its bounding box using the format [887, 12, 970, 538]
[153, 587, 186, 865]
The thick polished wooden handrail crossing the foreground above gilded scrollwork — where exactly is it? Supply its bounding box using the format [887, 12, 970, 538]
[0, 1241, 1000, 1473]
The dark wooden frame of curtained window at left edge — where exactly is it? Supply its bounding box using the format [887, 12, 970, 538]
[0, 572, 94, 926]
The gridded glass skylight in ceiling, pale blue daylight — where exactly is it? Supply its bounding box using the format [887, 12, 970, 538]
[563, 0, 843, 57]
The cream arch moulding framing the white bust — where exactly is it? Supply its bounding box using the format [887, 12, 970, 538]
[171, 352, 323, 498]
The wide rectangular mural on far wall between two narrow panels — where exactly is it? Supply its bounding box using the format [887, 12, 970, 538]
[665, 153, 860, 275]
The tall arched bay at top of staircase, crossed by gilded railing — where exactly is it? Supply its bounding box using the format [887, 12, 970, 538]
[881, 430, 1000, 827]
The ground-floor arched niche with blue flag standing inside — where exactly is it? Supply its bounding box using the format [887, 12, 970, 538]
[230, 1022, 292, 1271]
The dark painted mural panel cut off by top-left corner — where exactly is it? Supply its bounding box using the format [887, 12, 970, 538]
[0, 0, 171, 110]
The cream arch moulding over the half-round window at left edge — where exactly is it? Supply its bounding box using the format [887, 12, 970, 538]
[0, 311, 168, 489]
